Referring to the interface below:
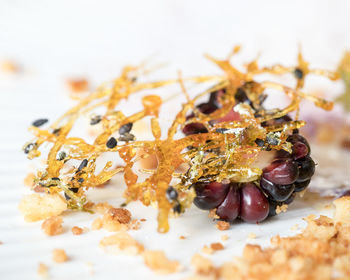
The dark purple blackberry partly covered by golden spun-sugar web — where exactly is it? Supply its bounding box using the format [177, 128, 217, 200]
[183, 88, 315, 223]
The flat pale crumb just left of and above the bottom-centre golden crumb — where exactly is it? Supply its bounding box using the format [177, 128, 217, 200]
[100, 231, 144, 255]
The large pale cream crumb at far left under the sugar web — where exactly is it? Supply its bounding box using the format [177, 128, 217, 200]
[18, 194, 67, 222]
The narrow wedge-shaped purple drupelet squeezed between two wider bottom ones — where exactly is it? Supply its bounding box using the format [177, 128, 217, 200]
[216, 184, 240, 222]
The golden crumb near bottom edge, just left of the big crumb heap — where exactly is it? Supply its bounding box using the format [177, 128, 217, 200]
[142, 250, 180, 274]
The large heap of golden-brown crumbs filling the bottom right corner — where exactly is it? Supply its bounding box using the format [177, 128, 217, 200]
[188, 196, 350, 280]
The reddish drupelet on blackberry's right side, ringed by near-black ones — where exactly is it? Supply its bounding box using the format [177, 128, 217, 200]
[263, 159, 298, 185]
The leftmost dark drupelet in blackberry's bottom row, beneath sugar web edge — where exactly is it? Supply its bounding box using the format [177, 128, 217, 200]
[193, 182, 229, 210]
